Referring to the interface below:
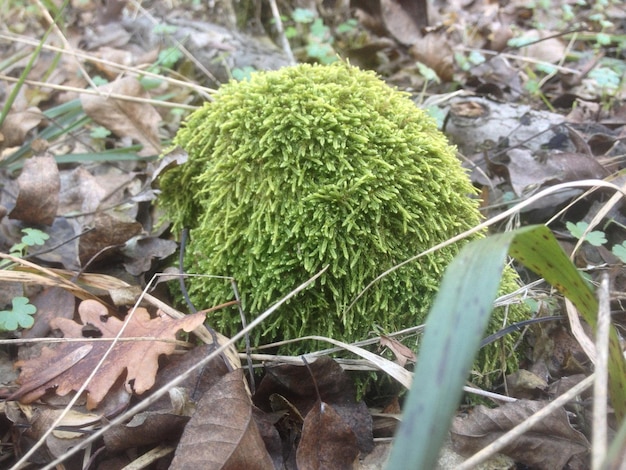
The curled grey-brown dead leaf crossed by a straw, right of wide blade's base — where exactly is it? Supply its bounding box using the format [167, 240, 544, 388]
[451, 400, 589, 470]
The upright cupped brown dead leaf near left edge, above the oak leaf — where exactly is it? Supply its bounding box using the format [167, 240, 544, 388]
[9, 154, 61, 225]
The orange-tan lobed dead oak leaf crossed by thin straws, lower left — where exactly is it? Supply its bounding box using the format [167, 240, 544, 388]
[12, 300, 205, 409]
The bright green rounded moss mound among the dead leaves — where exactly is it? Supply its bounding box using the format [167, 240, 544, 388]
[161, 63, 522, 378]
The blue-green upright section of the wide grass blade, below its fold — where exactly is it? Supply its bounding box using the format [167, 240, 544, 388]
[388, 227, 515, 470]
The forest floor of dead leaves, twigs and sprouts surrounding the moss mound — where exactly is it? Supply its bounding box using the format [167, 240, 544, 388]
[0, 0, 626, 470]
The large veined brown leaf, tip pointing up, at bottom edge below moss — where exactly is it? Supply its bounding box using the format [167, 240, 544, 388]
[170, 369, 274, 470]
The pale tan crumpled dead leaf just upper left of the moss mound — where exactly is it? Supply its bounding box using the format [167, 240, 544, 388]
[80, 77, 161, 157]
